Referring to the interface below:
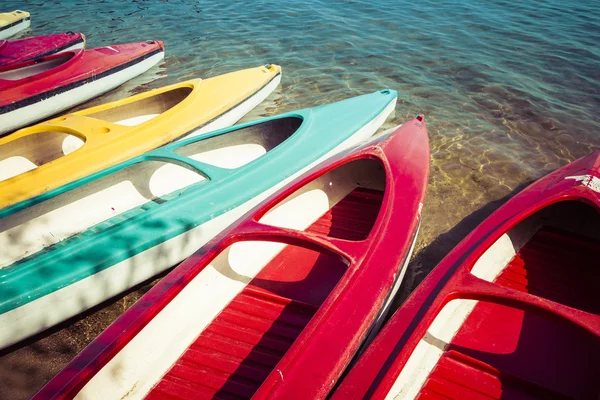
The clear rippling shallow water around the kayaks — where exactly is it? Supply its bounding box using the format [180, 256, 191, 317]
[0, 0, 600, 398]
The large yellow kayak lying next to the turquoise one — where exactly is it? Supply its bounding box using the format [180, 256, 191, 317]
[0, 65, 281, 212]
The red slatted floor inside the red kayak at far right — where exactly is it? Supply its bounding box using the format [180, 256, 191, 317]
[418, 227, 600, 399]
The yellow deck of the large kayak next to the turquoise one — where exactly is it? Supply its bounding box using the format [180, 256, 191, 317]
[0, 65, 281, 209]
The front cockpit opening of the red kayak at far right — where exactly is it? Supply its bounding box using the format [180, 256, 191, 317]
[471, 201, 600, 304]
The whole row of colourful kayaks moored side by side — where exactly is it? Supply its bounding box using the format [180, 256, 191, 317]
[0, 7, 600, 399]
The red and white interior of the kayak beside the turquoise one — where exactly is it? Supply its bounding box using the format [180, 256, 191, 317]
[79, 155, 385, 398]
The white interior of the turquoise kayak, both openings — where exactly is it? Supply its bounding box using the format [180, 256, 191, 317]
[0, 117, 302, 268]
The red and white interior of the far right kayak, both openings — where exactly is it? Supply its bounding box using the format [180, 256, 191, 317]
[393, 201, 600, 399]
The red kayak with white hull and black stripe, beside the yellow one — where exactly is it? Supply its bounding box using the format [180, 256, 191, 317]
[0, 40, 165, 134]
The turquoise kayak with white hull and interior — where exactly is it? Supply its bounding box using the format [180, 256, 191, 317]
[0, 90, 397, 347]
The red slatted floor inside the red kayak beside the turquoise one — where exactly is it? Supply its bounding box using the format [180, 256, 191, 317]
[148, 188, 383, 399]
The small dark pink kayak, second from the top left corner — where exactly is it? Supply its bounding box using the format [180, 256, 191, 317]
[0, 32, 85, 67]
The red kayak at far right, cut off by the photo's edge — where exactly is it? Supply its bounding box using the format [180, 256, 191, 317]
[333, 151, 600, 400]
